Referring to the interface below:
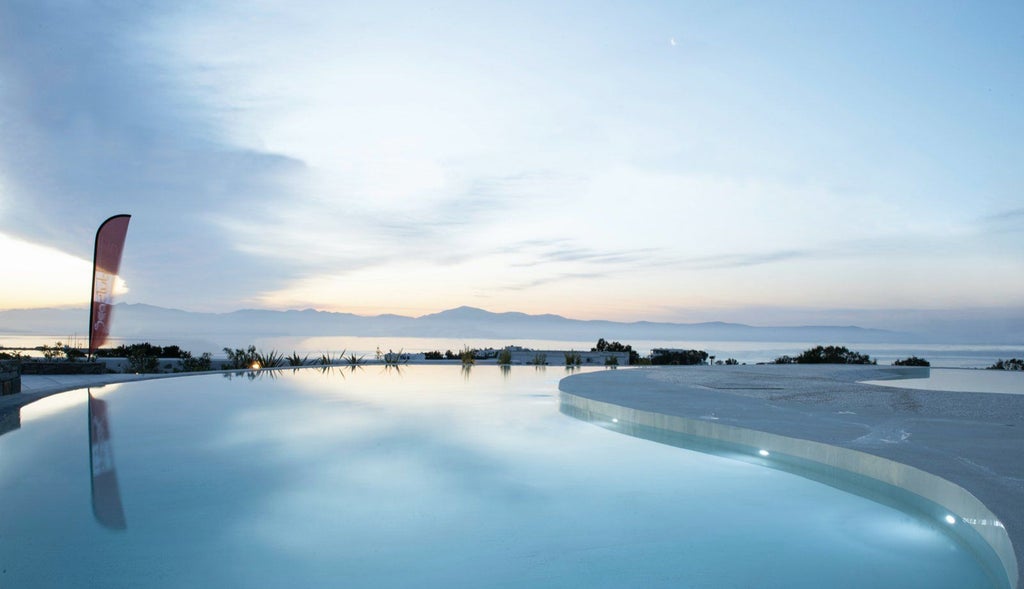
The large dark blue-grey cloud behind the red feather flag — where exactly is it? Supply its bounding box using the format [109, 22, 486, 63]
[0, 1, 303, 306]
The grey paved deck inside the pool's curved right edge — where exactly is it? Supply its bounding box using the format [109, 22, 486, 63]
[560, 365, 1024, 587]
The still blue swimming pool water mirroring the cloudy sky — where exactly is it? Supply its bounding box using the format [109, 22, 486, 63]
[0, 366, 1007, 587]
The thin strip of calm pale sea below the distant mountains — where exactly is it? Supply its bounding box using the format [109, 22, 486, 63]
[0, 334, 1024, 368]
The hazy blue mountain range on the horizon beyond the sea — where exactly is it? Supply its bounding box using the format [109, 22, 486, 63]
[0, 304, 922, 344]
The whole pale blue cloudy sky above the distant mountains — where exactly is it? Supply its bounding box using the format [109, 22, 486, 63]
[0, 0, 1024, 327]
